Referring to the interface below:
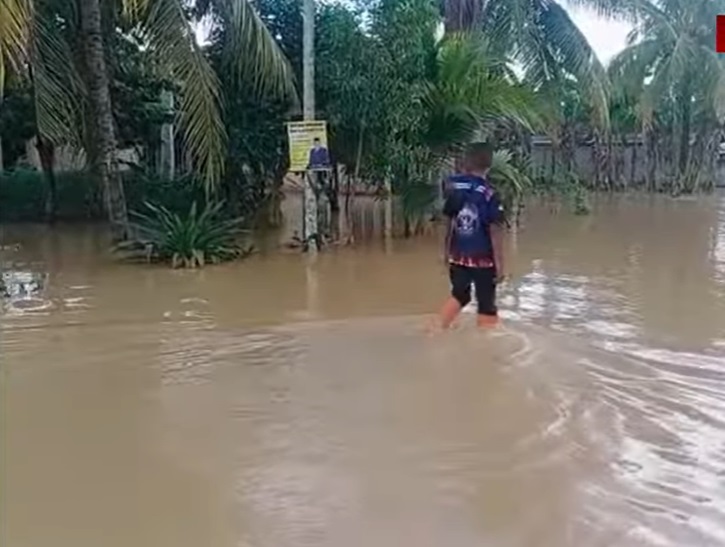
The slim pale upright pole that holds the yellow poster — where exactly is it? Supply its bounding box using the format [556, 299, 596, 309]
[302, 0, 318, 254]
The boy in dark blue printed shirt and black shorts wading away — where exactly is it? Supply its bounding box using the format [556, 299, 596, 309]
[440, 143, 505, 329]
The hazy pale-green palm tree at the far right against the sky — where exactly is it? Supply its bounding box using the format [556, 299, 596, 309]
[609, 0, 725, 191]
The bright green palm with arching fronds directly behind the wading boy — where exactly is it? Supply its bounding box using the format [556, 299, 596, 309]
[393, 33, 542, 233]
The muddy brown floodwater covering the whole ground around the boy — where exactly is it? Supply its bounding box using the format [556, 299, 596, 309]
[0, 196, 725, 547]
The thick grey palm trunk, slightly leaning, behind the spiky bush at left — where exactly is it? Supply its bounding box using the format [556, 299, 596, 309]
[79, 0, 129, 240]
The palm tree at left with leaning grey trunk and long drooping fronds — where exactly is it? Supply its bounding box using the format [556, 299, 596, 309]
[6, 0, 294, 238]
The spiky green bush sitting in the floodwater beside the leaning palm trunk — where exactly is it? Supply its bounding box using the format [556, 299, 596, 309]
[117, 202, 251, 268]
